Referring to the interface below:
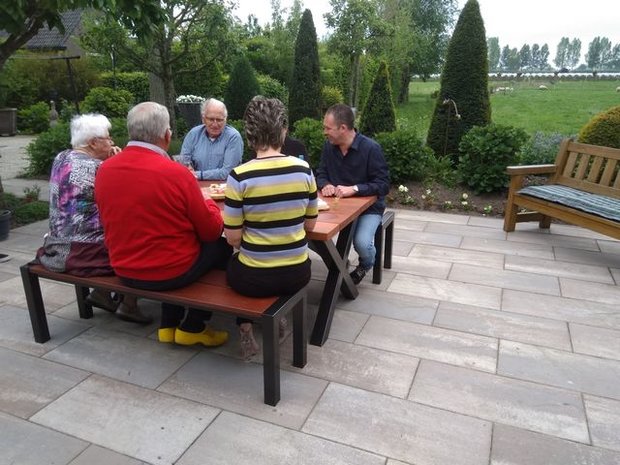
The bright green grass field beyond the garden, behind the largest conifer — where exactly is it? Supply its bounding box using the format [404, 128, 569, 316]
[396, 80, 620, 138]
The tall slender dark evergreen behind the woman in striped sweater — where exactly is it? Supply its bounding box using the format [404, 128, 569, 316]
[288, 10, 321, 126]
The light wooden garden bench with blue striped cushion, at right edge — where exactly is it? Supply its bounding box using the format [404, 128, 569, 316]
[504, 139, 620, 239]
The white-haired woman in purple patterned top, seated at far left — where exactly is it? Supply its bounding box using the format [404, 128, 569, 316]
[37, 114, 151, 323]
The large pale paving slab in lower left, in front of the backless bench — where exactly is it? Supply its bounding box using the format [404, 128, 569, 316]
[31, 375, 219, 465]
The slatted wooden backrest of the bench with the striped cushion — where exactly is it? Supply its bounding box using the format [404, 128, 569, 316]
[550, 139, 620, 198]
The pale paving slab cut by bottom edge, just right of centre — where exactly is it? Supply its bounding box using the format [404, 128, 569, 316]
[302, 384, 491, 465]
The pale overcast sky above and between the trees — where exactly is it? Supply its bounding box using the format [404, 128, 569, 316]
[236, 0, 620, 62]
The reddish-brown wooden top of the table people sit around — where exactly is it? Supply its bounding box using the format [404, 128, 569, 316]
[199, 181, 377, 241]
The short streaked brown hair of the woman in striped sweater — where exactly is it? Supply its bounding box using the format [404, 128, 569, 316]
[243, 95, 288, 151]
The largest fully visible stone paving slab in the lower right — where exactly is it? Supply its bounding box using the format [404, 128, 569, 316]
[409, 360, 590, 443]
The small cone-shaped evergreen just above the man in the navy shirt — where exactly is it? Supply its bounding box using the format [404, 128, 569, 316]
[360, 61, 396, 137]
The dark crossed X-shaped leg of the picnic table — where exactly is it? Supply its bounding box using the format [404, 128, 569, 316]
[310, 221, 359, 346]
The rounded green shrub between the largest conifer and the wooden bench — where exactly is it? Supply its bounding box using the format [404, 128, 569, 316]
[458, 124, 527, 194]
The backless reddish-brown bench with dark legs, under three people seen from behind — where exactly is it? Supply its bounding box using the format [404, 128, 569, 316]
[21, 264, 307, 405]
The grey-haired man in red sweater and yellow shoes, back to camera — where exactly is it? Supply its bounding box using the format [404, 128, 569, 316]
[95, 102, 232, 346]
